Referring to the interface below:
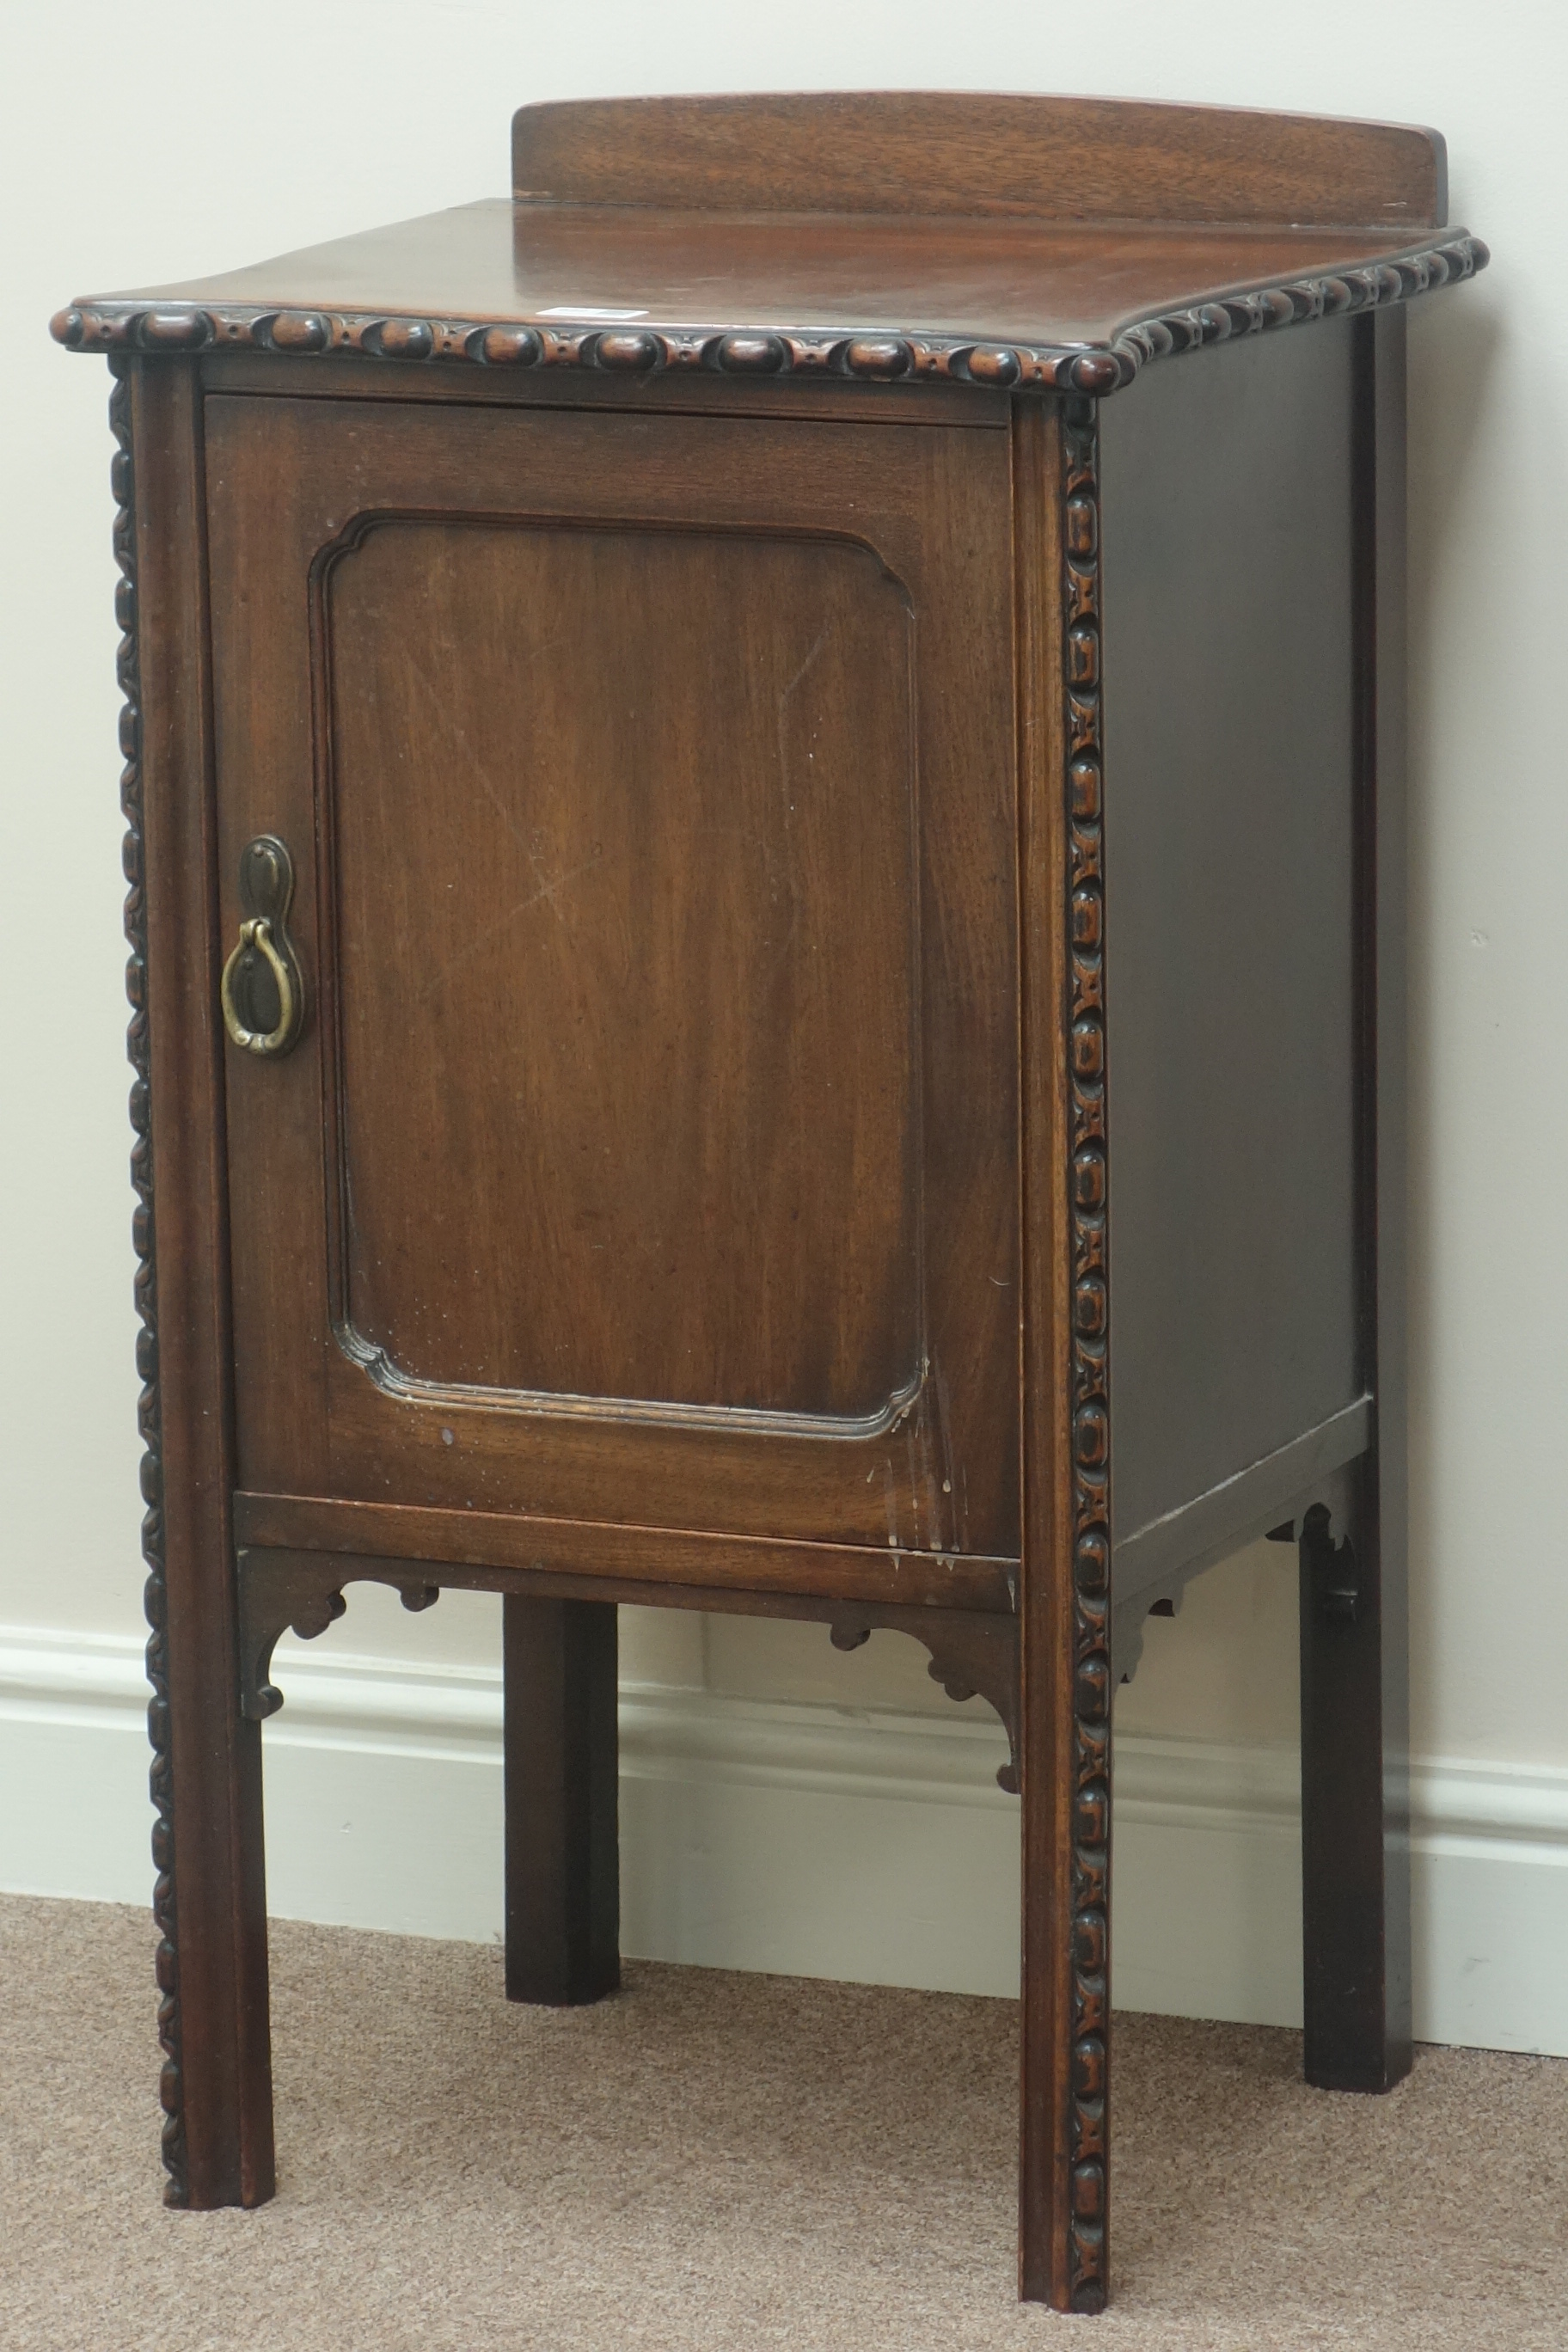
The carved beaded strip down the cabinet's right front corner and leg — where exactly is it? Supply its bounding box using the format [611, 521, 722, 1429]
[1060, 400, 1112, 2312]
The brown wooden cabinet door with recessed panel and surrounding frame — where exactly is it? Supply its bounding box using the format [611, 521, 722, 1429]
[207, 395, 1018, 1554]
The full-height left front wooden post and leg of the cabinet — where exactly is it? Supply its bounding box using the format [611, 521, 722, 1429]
[129, 362, 273, 2206]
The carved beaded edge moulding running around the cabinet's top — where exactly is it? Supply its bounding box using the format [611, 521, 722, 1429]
[49, 233, 1491, 397]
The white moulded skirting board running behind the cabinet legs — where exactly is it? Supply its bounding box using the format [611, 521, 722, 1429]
[0, 1630, 1568, 2055]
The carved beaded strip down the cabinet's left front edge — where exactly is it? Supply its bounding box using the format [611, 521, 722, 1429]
[108, 358, 191, 2206]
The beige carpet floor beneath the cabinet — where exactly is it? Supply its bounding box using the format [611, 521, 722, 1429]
[0, 1896, 1568, 2352]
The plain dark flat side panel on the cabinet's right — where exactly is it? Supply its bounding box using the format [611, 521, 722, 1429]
[1103, 322, 1361, 1543]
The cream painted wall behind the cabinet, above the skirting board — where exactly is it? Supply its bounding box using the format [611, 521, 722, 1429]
[0, 0, 1568, 1834]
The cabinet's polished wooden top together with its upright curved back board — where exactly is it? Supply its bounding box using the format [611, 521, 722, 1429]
[52, 92, 1488, 395]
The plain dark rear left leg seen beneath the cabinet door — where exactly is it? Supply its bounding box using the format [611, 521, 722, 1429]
[500, 1592, 621, 2009]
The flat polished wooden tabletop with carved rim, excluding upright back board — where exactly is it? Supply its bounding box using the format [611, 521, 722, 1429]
[52, 202, 1485, 395]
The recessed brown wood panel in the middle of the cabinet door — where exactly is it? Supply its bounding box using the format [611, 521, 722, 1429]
[322, 518, 924, 1428]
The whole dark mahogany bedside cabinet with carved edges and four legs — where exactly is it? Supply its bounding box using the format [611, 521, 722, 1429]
[54, 96, 1485, 2310]
